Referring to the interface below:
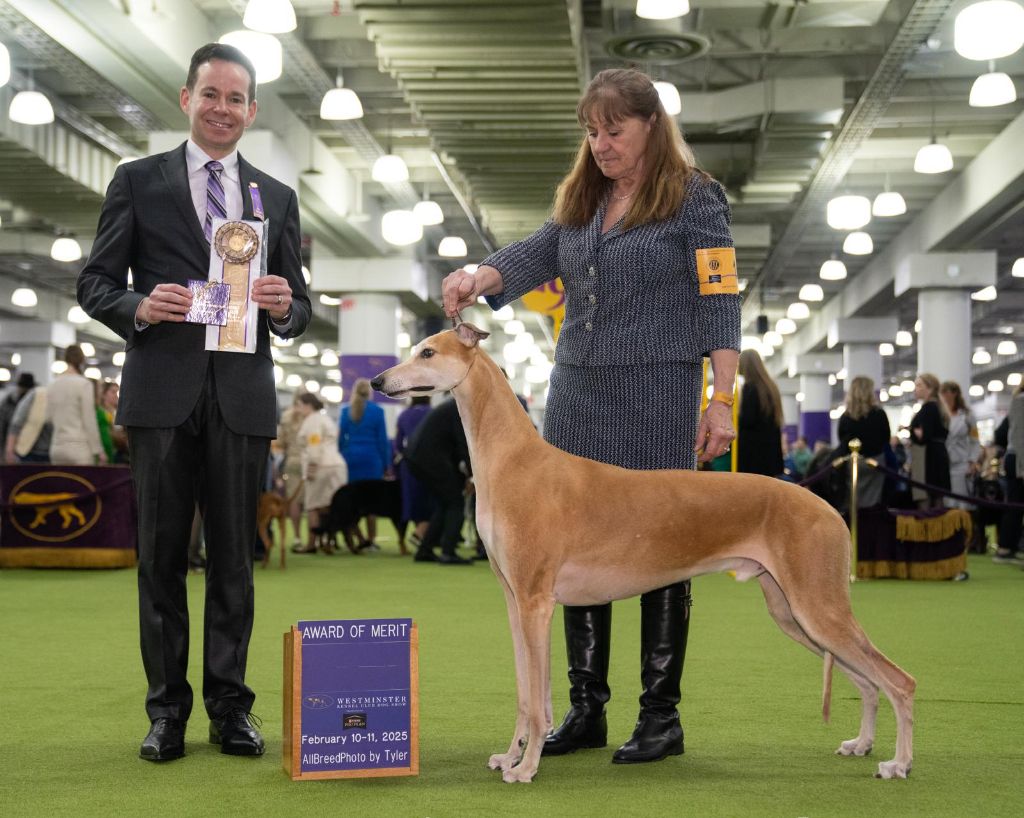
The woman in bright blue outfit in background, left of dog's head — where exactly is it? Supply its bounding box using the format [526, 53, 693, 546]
[338, 378, 391, 548]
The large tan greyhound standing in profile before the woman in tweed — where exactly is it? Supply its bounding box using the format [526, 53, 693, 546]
[373, 324, 915, 782]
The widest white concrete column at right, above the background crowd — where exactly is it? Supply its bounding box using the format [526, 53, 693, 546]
[918, 290, 973, 394]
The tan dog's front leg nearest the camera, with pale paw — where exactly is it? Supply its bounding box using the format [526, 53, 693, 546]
[502, 596, 555, 784]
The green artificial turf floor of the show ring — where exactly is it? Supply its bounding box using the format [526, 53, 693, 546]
[0, 539, 1024, 818]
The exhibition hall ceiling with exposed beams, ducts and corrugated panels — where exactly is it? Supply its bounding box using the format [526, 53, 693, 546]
[0, 0, 1024, 395]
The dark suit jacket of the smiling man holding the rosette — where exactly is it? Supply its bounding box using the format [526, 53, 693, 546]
[78, 143, 311, 438]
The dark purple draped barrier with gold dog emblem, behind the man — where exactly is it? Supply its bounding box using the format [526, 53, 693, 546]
[0, 464, 137, 568]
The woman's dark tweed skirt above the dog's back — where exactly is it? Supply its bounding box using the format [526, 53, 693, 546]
[544, 361, 703, 469]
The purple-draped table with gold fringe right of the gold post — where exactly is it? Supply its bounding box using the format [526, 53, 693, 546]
[857, 506, 971, 579]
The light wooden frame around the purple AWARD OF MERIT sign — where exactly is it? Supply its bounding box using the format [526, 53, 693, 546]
[282, 622, 420, 781]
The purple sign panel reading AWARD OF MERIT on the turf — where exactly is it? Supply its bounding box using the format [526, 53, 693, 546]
[298, 619, 413, 773]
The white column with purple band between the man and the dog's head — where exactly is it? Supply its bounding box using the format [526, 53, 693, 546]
[338, 293, 404, 435]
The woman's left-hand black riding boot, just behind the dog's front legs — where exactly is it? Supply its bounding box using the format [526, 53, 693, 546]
[544, 604, 611, 756]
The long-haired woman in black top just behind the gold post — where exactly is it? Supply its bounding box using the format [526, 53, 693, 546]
[836, 375, 892, 508]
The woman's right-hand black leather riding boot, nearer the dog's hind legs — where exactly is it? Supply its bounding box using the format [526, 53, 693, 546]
[611, 579, 690, 764]
